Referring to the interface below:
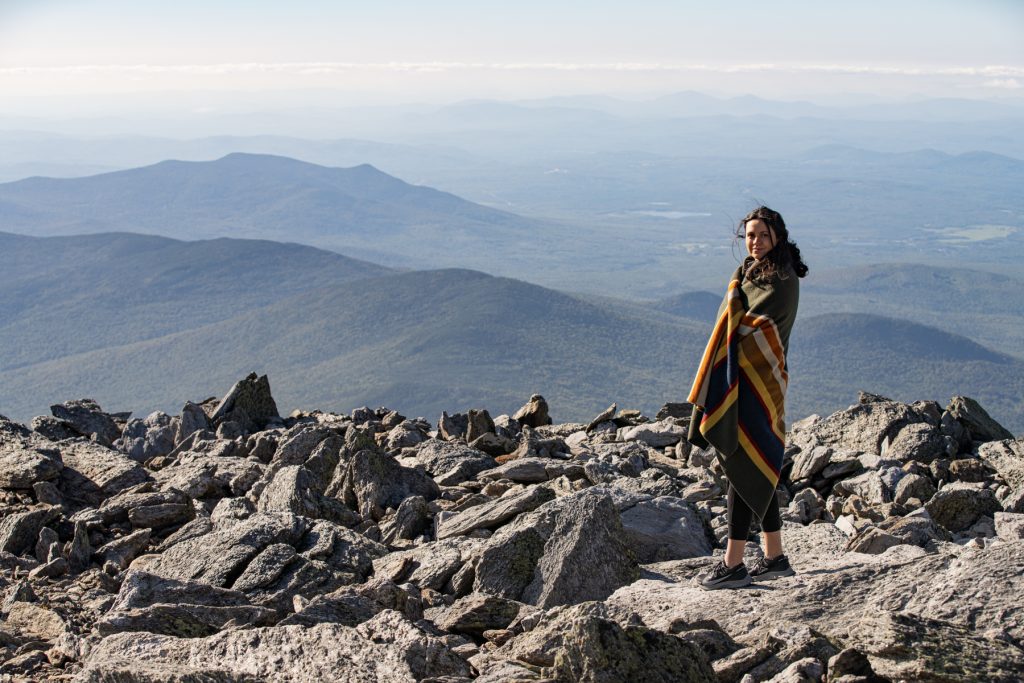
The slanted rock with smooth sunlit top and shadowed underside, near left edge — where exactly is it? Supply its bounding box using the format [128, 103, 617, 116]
[59, 441, 150, 506]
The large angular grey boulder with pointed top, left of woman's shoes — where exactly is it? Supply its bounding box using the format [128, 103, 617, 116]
[473, 490, 639, 607]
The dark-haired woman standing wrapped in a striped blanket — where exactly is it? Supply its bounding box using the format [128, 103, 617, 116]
[688, 207, 807, 590]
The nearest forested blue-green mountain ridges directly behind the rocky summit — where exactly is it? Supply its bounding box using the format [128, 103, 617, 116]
[0, 229, 1024, 432]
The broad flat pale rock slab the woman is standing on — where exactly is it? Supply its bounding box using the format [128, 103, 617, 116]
[607, 530, 1024, 645]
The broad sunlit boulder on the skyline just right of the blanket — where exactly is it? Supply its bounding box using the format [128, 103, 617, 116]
[793, 400, 928, 454]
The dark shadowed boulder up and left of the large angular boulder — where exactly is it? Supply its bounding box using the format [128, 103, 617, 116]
[342, 450, 440, 519]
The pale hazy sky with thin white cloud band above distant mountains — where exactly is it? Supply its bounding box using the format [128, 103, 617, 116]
[0, 0, 1024, 114]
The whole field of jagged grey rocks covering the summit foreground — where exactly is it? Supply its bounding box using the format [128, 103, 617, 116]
[0, 375, 1024, 683]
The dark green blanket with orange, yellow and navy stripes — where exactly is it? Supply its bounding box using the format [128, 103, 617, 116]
[688, 267, 799, 517]
